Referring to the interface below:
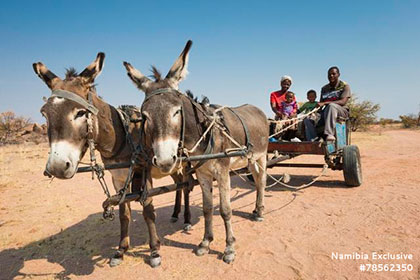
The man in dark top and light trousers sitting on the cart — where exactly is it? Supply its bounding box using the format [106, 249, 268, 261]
[308, 66, 351, 141]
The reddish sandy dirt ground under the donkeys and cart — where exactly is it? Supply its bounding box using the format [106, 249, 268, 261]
[0, 130, 420, 279]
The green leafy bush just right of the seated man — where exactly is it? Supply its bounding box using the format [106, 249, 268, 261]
[347, 95, 381, 131]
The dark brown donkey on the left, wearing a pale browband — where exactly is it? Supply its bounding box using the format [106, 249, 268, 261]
[33, 53, 191, 266]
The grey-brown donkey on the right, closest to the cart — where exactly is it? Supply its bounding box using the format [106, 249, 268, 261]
[124, 41, 269, 263]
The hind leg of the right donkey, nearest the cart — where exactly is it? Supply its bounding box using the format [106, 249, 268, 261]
[248, 156, 267, 222]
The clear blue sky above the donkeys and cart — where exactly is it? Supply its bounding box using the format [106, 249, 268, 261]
[0, 1, 420, 122]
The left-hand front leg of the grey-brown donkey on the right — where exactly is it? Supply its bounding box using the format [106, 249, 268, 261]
[195, 173, 213, 256]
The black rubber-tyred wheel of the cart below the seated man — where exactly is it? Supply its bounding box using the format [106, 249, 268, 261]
[343, 145, 363, 187]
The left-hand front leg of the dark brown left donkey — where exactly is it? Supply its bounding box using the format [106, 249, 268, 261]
[109, 202, 131, 267]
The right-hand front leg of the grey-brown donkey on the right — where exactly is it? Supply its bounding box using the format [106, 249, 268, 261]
[217, 169, 235, 263]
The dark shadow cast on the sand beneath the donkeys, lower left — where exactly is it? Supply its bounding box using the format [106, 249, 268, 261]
[0, 203, 201, 279]
